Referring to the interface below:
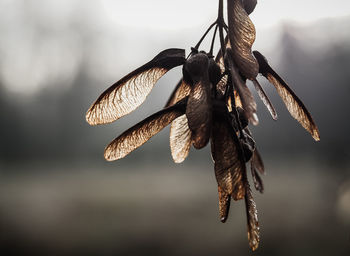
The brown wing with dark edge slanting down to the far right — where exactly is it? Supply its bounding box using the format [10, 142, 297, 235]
[254, 51, 320, 141]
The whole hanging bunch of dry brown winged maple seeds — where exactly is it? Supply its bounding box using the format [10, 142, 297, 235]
[86, 0, 320, 250]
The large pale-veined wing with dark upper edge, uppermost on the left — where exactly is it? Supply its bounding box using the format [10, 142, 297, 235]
[86, 49, 185, 125]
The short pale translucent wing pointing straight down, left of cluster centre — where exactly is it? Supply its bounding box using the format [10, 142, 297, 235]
[170, 115, 192, 163]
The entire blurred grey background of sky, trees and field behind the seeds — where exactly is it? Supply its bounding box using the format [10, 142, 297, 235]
[0, 0, 350, 256]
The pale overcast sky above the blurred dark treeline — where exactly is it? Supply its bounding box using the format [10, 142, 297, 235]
[0, 0, 350, 93]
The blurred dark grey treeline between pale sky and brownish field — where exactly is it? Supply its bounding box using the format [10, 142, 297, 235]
[0, 25, 350, 164]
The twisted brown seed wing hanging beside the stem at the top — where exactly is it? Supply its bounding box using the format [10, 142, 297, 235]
[227, 0, 259, 80]
